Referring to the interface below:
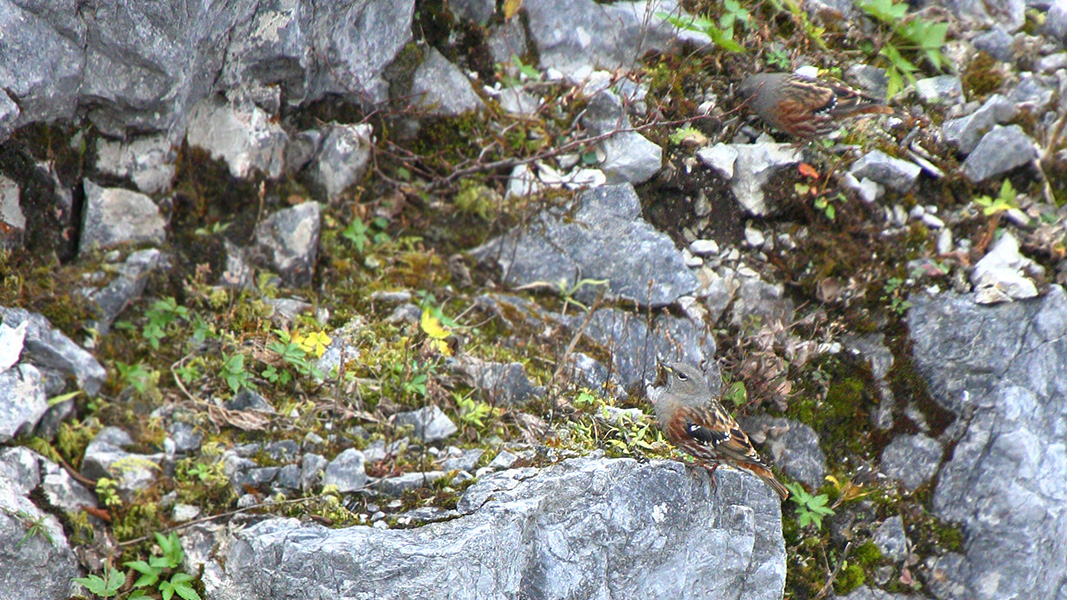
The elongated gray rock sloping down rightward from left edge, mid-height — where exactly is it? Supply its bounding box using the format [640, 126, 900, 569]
[0, 306, 108, 396]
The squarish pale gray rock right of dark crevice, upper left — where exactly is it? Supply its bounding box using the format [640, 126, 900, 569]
[78, 179, 166, 255]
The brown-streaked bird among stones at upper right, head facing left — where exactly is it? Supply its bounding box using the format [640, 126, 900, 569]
[737, 73, 894, 140]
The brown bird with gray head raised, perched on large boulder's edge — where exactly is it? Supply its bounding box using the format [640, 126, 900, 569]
[649, 363, 790, 501]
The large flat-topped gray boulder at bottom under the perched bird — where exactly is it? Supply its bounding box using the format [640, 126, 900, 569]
[203, 459, 785, 600]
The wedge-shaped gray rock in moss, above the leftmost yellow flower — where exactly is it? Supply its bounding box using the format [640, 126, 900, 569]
[256, 201, 322, 286]
